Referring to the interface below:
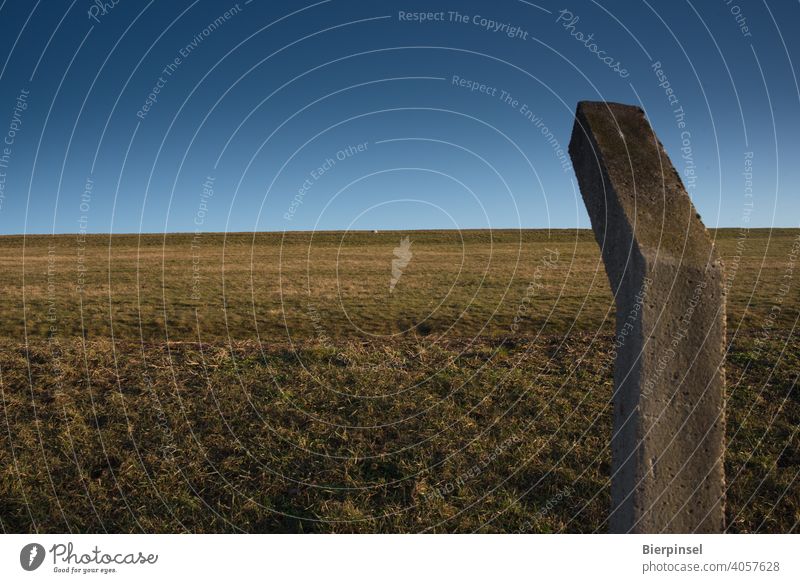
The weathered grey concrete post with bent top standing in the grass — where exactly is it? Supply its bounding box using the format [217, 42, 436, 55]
[569, 102, 725, 533]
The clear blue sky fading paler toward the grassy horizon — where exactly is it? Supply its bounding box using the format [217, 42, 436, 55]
[0, 0, 800, 233]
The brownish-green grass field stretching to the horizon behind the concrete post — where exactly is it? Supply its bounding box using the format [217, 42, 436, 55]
[0, 230, 800, 532]
